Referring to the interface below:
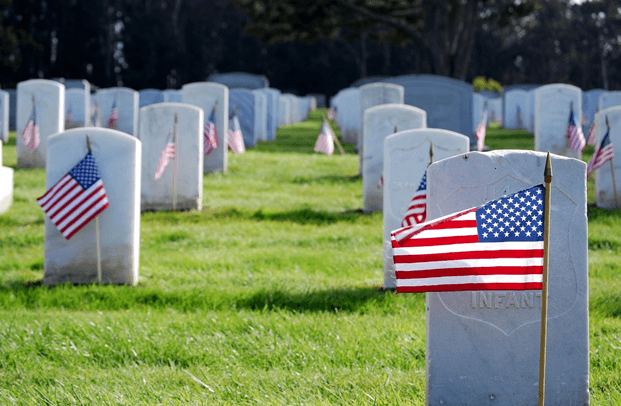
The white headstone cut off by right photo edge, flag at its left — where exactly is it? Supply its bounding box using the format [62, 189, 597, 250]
[591, 106, 621, 209]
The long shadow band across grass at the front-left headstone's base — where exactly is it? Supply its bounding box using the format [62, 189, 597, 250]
[0, 281, 425, 313]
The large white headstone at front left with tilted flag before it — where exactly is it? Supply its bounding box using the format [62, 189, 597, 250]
[43, 128, 141, 285]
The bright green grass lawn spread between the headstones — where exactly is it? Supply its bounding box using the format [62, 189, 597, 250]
[0, 112, 621, 405]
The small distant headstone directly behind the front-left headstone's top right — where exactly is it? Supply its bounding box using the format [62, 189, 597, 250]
[97, 87, 138, 135]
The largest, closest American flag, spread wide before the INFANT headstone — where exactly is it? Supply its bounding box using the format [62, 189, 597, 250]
[391, 185, 545, 292]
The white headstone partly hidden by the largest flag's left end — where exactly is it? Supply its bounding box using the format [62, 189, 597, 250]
[383, 128, 470, 289]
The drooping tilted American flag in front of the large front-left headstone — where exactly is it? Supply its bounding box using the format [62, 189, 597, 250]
[37, 151, 108, 240]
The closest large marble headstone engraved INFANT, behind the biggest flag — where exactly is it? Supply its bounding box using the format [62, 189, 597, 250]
[426, 150, 589, 406]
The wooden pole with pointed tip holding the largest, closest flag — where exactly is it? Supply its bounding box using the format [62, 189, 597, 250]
[538, 151, 552, 406]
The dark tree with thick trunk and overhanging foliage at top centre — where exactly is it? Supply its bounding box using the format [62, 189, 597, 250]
[225, 0, 535, 80]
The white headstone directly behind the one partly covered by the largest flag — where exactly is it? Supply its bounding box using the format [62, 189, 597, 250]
[361, 104, 427, 212]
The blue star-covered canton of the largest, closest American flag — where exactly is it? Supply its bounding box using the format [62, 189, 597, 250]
[476, 186, 545, 242]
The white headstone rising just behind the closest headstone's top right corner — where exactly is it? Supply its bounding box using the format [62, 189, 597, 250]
[535, 83, 582, 159]
